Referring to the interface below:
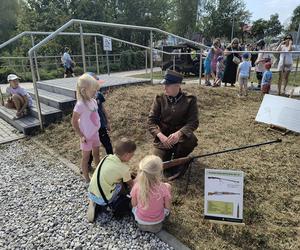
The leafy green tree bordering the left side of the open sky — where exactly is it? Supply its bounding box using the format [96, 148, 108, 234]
[198, 0, 250, 40]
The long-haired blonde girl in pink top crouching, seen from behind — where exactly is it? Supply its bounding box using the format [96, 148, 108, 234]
[130, 155, 171, 233]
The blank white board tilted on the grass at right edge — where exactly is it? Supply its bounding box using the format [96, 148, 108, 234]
[255, 95, 300, 133]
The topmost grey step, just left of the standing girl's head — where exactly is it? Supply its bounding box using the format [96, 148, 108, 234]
[37, 78, 76, 99]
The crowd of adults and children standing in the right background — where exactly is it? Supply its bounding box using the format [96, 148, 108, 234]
[204, 35, 293, 96]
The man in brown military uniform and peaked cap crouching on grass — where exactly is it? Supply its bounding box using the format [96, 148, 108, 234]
[148, 70, 199, 176]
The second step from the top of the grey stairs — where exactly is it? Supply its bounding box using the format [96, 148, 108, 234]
[27, 89, 76, 114]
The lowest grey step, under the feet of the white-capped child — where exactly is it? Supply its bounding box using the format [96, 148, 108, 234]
[0, 106, 40, 135]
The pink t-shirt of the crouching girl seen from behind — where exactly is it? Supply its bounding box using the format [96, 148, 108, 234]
[130, 183, 171, 222]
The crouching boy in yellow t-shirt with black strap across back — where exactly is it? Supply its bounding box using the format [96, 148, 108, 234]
[87, 138, 136, 222]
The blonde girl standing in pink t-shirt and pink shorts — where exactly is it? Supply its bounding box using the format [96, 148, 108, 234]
[72, 74, 100, 182]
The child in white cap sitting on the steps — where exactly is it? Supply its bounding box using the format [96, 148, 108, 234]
[5, 74, 32, 119]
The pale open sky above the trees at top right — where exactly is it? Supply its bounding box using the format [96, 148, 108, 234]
[244, 0, 300, 25]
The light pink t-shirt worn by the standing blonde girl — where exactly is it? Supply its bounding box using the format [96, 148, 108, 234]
[73, 99, 100, 139]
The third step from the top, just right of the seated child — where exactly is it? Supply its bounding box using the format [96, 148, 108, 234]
[31, 100, 62, 125]
